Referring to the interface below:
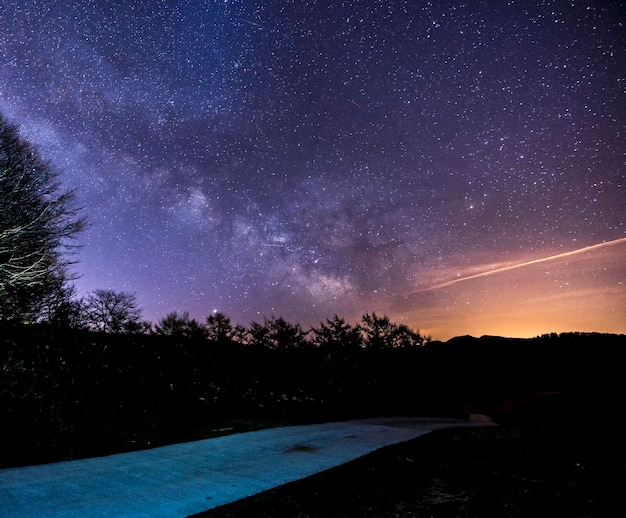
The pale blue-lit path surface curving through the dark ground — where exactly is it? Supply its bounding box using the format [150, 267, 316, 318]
[0, 417, 488, 518]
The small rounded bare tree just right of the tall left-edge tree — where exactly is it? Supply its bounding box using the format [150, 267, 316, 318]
[84, 290, 143, 333]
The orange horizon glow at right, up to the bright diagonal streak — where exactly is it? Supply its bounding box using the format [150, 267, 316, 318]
[393, 238, 626, 340]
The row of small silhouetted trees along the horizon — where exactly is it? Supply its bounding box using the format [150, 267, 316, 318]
[41, 290, 431, 350]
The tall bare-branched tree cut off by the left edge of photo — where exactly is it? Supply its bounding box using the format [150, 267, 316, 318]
[0, 115, 85, 320]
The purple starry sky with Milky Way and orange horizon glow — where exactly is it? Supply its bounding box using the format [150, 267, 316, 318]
[0, 0, 626, 339]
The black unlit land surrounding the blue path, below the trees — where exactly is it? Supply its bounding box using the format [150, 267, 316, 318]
[0, 332, 626, 517]
